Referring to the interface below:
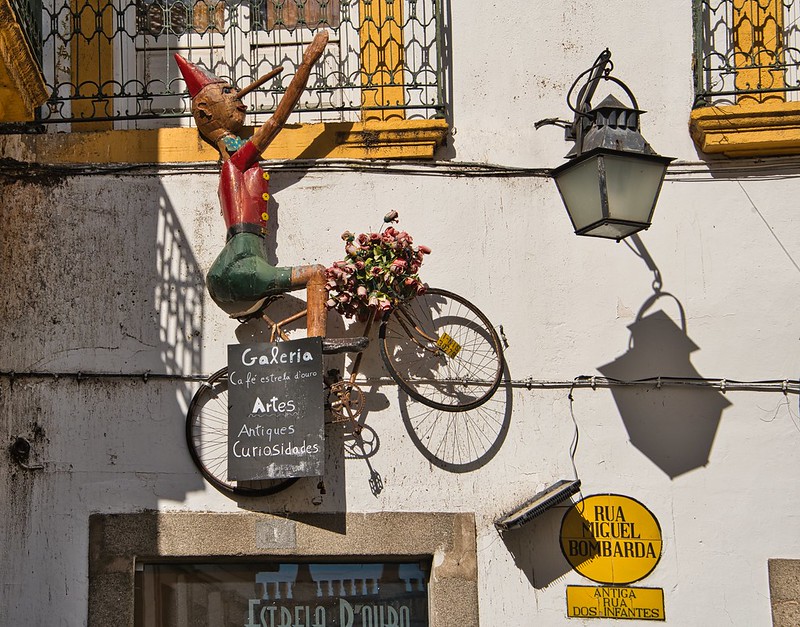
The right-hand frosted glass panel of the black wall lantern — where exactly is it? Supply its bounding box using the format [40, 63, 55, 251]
[600, 154, 667, 223]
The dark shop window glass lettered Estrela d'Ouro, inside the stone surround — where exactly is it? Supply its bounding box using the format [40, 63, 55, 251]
[134, 559, 430, 627]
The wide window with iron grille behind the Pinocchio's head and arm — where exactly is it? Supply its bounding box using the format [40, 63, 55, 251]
[37, 0, 445, 130]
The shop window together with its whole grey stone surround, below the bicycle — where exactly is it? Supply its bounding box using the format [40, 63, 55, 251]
[88, 512, 479, 627]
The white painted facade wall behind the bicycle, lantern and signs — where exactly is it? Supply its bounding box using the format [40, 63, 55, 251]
[0, 0, 800, 627]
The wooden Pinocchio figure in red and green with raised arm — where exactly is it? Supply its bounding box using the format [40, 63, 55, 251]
[175, 31, 328, 336]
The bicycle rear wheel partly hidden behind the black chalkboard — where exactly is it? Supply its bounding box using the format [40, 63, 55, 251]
[186, 368, 297, 496]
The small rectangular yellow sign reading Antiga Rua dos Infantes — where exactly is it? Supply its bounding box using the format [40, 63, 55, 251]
[567, 586, 666, 620]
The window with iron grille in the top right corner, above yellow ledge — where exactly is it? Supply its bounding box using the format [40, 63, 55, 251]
[693, 0, 800, 107]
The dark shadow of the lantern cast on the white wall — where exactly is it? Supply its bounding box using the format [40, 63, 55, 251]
[598, 290, 731, 479]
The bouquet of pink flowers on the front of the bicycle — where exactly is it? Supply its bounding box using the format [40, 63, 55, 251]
[325, 211, 431, 320]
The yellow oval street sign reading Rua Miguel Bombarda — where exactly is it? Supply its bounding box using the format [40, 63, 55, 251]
[561, 494, 661, 584]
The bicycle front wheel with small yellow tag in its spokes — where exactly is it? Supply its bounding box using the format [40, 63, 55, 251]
[380, 288, 503, 411]
